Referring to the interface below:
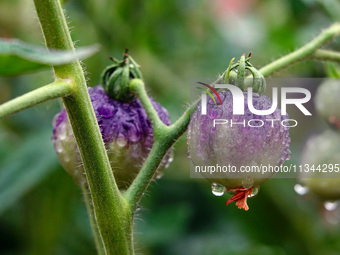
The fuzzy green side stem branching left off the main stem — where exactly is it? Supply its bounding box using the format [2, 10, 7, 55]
[0, 81, 71, 119]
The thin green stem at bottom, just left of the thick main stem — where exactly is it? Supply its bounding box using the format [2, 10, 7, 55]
[81, 184, 105, 255]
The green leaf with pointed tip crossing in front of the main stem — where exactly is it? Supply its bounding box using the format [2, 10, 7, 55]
[0, 38, 99, 76]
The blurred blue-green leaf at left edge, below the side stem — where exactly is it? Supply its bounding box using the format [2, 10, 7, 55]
[0, 132, 58, 214]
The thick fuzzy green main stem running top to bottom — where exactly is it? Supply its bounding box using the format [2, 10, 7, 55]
[34, 0, 133, 255]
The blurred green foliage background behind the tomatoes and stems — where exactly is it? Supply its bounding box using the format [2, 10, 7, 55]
[0, 0, 340, 255]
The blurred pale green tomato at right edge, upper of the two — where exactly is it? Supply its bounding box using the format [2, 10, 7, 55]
[314, 79, 340, 128]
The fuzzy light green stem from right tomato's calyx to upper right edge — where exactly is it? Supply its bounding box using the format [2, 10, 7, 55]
[259, 23, 340, 76]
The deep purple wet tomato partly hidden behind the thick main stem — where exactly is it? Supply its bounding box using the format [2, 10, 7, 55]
[53, 86, 171, 189]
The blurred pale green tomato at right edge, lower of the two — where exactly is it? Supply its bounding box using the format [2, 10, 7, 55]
[300, 130, 340, 200]
